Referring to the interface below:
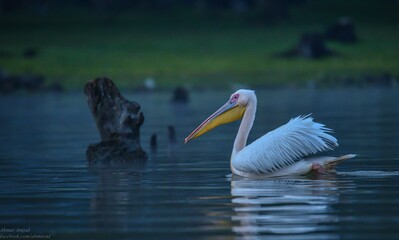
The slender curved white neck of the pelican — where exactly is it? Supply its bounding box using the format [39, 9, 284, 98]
[230, 95, 256, 161]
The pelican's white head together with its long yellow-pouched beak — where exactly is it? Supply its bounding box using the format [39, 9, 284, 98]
[184, 89, 256, 143]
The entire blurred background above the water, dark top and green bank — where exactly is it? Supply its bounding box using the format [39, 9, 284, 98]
[0, 0, 399, 89]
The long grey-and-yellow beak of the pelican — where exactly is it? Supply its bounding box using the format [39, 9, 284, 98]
[184, 101, 245, 143]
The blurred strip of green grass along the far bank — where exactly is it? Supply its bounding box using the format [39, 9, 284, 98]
[0, 1, 399, 88]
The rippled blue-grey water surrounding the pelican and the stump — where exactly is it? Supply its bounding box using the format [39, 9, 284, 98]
[0, 89, 399, 239]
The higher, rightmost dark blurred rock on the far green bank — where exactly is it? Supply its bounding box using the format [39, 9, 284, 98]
[324, 17, 358, 43]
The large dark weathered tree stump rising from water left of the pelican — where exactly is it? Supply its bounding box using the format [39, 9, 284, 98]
[84, 78, 147, 164]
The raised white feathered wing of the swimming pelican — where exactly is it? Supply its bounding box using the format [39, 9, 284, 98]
[232, 115, 338, 174]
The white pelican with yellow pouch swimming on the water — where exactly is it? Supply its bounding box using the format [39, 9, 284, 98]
[184, 89, 356, 177]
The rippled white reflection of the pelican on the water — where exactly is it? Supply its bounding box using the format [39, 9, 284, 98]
[231, 175, 350, 239]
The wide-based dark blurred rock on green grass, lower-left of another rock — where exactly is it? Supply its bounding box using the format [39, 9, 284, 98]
[277, 33, 335, 59]
